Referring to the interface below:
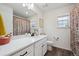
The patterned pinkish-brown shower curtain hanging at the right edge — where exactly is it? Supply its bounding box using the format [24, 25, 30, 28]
[70, 4, 79, 56]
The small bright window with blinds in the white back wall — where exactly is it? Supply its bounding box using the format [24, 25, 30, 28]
[57, 15, 69, 28]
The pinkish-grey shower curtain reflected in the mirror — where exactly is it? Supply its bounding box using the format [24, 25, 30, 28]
[13, 16, 30, 35]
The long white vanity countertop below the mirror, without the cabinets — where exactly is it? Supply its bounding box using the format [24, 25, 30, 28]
[0, 35, 46, 56]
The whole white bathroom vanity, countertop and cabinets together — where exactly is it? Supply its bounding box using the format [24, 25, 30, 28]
[0, 35, 47, 56]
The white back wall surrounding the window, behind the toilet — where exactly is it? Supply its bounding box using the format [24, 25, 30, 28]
[44, 6, 74, 50]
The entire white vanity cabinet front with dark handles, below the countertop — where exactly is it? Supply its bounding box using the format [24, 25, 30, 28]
[11, 37, 47, 56]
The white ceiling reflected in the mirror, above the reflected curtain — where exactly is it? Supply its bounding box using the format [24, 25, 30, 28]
[5, 3, 35, 18]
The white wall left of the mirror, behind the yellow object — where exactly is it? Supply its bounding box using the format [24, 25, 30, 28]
[0, 4, 13, 33]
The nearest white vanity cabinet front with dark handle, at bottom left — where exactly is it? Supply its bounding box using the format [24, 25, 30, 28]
[13, 45, 33, 56]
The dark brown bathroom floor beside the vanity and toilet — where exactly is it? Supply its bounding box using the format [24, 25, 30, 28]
[45, 47, 74, 56]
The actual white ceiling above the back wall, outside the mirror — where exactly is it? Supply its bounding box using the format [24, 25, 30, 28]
[36, 3, 73, 12]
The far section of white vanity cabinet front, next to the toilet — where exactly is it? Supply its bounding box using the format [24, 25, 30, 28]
[35, 38, 47, 56]
